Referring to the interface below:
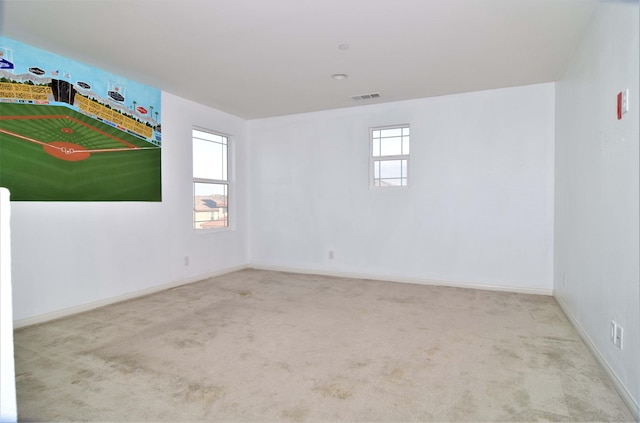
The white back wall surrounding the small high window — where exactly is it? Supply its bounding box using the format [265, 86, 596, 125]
[248, 84, 554, 292]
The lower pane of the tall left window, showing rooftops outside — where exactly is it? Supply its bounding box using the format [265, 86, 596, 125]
[193, 182, 229, 229]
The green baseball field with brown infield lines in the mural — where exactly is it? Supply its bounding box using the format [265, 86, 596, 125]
[0, 103, 162, 201]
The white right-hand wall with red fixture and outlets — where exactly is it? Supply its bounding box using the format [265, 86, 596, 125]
[554, 2, 640, 416]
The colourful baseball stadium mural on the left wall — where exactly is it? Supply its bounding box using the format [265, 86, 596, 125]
[0, 37, 162, 201]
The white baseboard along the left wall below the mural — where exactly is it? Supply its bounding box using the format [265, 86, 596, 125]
[13, 265, 248, 329]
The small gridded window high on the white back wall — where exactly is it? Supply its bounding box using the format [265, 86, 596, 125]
[370, 125, 409, 187]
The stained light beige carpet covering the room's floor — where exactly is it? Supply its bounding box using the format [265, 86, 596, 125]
[15, 270, 632, 422]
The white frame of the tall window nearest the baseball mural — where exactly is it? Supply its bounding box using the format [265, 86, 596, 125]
[191, 126, 235, 233]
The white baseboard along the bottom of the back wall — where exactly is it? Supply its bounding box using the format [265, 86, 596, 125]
[249, 263, 553, 296]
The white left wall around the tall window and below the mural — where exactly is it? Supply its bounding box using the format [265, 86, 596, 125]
[12, 93, 247, 321]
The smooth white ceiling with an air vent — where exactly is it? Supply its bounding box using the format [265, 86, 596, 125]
[0, 0, 596, 119]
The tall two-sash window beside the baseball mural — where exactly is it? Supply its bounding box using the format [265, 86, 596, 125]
[192, 129, 229, 230]
